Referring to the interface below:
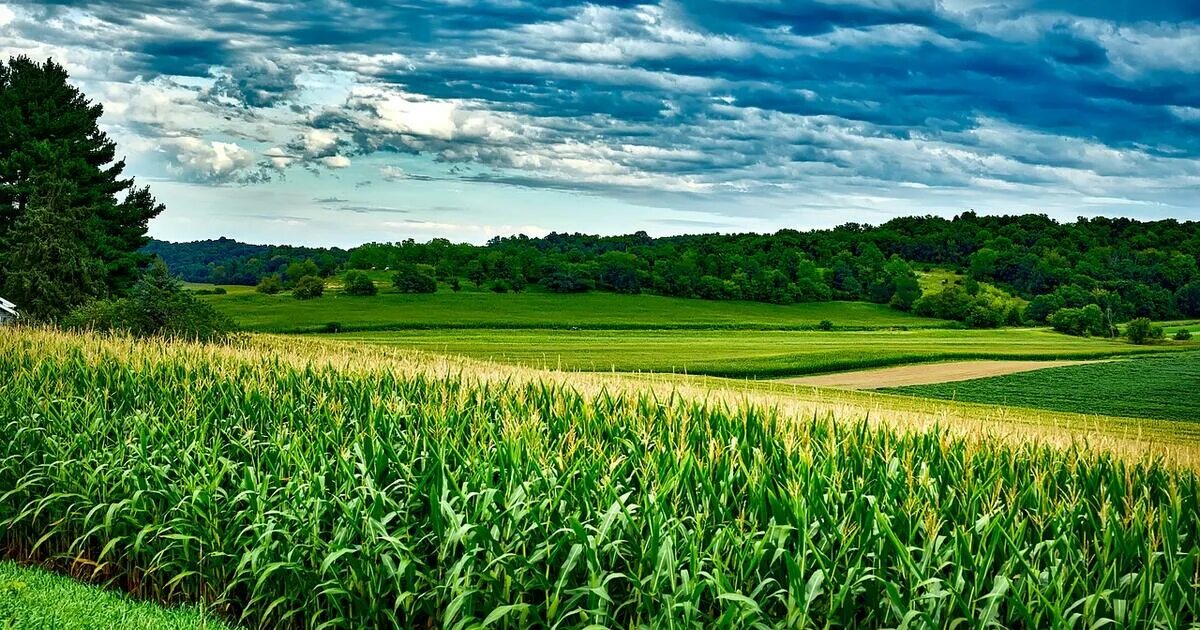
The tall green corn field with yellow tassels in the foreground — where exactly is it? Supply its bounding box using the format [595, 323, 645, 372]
[0, 330, 1200, 628]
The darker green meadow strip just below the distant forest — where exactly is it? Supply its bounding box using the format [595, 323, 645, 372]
[194, 287, 952, 332]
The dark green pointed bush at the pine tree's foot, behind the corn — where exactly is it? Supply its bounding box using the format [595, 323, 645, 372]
[62, 260, 235, 341]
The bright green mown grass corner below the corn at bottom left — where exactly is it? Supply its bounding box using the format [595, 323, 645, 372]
[0, 562, 228, 630]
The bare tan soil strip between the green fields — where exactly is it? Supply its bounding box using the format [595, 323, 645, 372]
[780, 361, 1098, 389]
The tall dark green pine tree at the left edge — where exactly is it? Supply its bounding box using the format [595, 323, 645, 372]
[0, 56, 163, 318]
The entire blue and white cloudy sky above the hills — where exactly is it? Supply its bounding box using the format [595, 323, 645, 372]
[0, 0, 1200, 245]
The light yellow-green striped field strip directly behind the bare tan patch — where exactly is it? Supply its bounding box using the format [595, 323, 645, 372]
[329, 329, 1198, 378]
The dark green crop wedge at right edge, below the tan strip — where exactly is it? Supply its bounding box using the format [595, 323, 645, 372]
[884, 353, 1200, 421]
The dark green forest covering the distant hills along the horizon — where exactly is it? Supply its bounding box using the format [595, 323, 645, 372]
[144, 212, 1200, 328]
